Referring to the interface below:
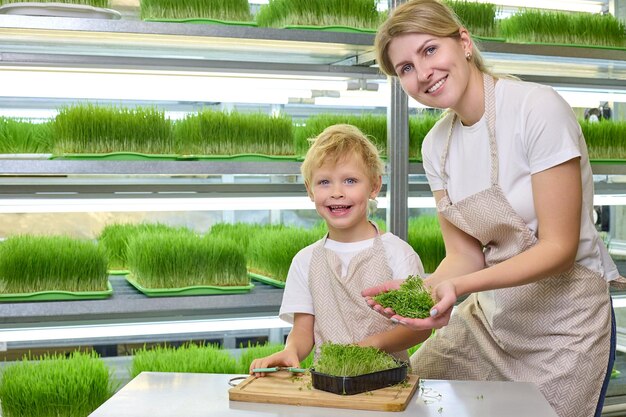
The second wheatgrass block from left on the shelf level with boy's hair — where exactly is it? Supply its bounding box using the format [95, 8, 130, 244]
[53, 104, 175, 154]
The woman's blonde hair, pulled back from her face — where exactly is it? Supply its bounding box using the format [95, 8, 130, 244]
[374, 0, 490, 77]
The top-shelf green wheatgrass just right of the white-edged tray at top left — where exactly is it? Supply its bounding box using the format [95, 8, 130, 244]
[140, 0, 253, 22]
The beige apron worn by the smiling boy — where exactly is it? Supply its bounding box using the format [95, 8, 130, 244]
[309, 225, 409, 361]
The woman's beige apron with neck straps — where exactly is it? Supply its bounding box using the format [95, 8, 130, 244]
[411, 76, 611, 417]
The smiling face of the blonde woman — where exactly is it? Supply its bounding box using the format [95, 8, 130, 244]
[388, 30, 472, 112]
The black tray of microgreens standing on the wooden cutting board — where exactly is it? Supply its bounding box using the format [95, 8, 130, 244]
[310, 342, 409, 395]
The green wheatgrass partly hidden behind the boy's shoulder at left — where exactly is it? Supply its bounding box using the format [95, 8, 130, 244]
[248, 227, 324, 281]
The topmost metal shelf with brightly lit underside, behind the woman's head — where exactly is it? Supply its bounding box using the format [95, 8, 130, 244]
[0, 15, 626, 91]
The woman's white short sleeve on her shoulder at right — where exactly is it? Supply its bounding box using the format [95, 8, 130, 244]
[522, 85, 582, 174]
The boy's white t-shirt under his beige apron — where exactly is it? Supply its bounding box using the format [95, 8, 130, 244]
[279, 233, 424, 323]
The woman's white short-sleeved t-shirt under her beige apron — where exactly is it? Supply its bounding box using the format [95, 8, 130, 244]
[422, 79, 619, 280]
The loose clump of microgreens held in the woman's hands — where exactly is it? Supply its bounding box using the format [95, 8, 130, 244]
[372, 275, 435, 319]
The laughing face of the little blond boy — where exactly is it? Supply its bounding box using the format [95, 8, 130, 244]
[307, 155, 381, 242]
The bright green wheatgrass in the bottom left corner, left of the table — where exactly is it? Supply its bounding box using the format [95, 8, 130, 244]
[0, 352, 116, 417]
